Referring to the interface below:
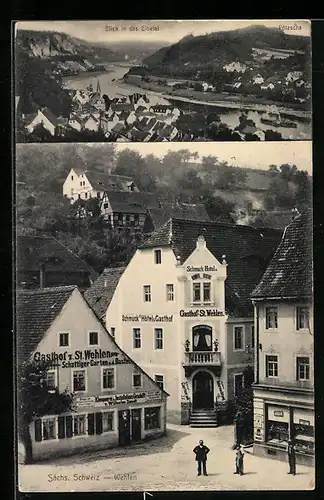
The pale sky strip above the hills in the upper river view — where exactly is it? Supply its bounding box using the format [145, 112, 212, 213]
[15, 19, 311, 44]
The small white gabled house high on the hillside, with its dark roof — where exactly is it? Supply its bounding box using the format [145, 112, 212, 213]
[63, 167, 138, 203]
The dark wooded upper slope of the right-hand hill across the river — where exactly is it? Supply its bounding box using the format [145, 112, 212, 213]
[144, 26, 310, 68]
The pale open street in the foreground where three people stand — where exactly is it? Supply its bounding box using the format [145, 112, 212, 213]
[19, 424, 315, 492]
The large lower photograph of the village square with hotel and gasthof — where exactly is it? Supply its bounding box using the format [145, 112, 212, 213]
[15, 141, 315, 496]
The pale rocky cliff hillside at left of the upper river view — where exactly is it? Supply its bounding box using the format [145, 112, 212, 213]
[16, 30, 118, 65]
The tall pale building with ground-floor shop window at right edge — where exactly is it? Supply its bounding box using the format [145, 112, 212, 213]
[252, 211, 315, 464]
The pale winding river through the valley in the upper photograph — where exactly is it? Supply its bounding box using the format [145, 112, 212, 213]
[64, 63, 311, 140]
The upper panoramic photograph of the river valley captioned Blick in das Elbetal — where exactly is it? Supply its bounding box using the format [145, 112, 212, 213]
[14, 19, 312, 143]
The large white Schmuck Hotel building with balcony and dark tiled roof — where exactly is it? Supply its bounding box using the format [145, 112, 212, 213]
[88, 218, 281, 426]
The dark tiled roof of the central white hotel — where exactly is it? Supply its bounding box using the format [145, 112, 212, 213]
[139, 218, 282, 317]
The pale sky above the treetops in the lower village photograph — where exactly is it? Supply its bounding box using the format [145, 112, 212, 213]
[95, 141, 312, 175]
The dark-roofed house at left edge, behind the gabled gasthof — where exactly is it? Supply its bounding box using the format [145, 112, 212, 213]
[16, 235, 97, 289]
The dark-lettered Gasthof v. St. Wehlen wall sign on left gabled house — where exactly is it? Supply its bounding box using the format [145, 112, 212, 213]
[34, 349, 132, 368]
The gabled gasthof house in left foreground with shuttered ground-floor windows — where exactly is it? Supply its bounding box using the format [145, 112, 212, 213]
[17, 287, 167, 461]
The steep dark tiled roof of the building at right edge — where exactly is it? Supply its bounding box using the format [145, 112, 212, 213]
[252, 210, 313, 299]
